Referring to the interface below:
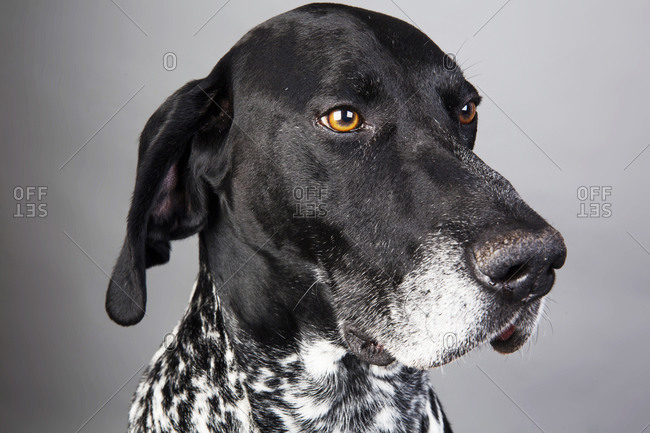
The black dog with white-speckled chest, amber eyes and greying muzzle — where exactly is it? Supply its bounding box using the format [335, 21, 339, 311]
[106, 4, 566, 433]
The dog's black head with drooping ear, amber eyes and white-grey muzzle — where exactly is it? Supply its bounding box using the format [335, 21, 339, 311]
[106, 4, 566, 368]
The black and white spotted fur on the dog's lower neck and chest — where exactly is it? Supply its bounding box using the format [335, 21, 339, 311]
[129, 274, 451, 433]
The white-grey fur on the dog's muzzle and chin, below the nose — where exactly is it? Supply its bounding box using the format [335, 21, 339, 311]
[376, 235, 542, 369]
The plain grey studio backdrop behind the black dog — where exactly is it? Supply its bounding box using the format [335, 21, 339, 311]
[0, 0, 650, 433]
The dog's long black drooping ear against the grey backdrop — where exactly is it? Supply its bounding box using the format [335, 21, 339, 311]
[106, 58, 232, 326]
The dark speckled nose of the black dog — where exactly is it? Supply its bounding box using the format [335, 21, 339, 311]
[470, 227, 566, 302]
